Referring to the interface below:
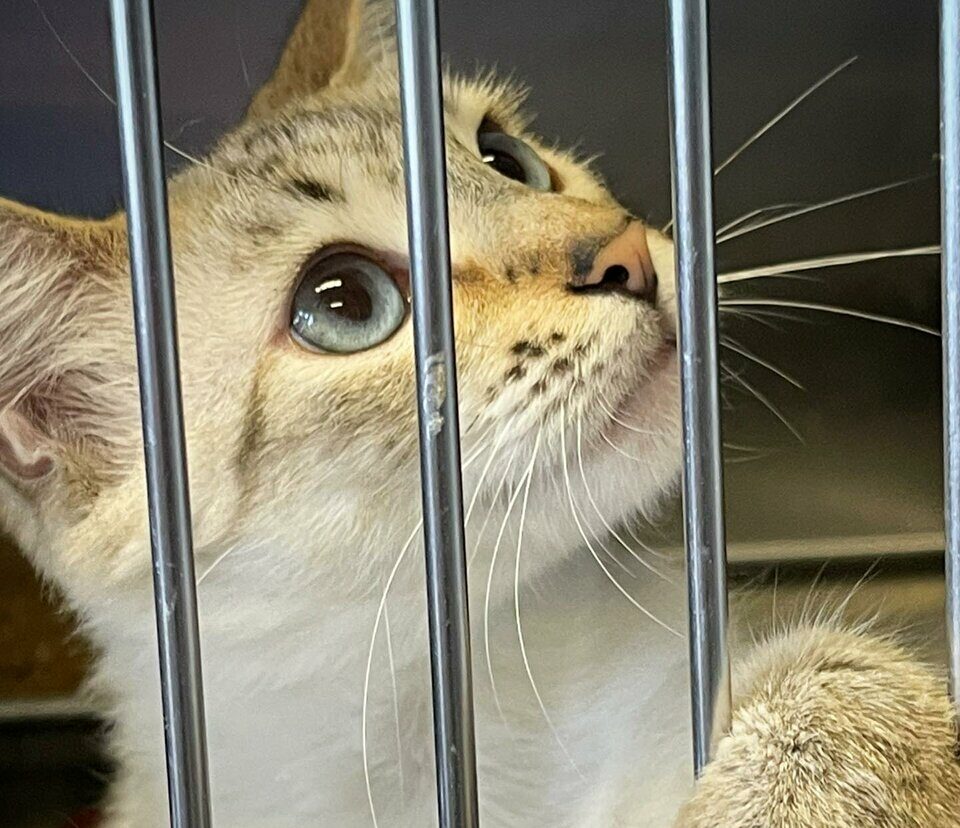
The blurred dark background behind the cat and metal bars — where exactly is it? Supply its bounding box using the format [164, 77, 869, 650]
[0, 0, 942, 826]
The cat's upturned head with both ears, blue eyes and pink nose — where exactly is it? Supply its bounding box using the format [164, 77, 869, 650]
[0, 0, 679, 596]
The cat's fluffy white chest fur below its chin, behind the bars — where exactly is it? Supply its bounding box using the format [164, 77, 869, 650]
[86, 528, 690, 828]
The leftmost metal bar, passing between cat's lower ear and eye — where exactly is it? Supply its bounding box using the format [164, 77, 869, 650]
[110, 0, 210, 828]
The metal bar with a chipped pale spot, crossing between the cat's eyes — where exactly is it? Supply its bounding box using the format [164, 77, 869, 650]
[397, 0, 478, 828]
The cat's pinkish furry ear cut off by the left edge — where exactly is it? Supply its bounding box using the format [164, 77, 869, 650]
[0, 199, 125, 482]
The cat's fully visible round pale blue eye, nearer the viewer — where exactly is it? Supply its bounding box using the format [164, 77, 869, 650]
[290, 252, 407, 354]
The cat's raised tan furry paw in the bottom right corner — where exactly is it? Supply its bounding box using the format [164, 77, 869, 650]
[676, 627, 960, 828]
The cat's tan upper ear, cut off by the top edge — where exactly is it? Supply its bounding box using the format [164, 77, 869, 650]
[247, 0, 394, 118]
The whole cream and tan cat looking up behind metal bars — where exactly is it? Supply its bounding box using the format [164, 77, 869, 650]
[0, 0, 960, 828]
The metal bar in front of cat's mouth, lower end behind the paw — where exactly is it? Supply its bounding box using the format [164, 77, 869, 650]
[669, 0, 730, 774]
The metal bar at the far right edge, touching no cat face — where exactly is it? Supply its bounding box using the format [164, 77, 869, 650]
[940, 0, 960, 704]
